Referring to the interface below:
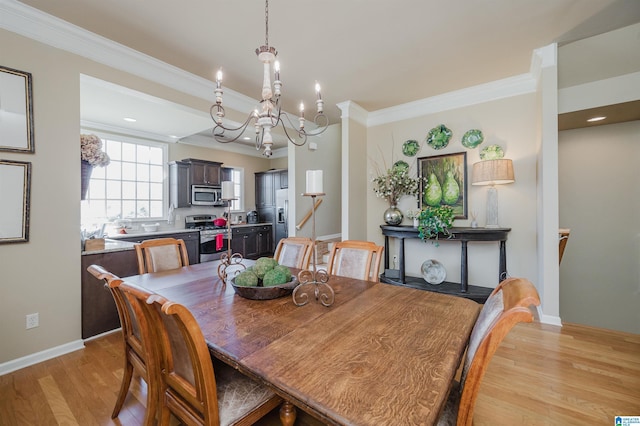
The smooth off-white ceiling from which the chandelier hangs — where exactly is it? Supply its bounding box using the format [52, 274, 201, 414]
[13, 0, 640, 148]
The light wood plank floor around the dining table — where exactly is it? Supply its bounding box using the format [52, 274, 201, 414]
[0, 324, 640, 426]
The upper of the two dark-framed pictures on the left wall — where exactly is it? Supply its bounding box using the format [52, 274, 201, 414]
[0, 66, 35, 153]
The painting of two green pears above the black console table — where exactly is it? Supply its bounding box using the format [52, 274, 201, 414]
[418, 152, 467, 219]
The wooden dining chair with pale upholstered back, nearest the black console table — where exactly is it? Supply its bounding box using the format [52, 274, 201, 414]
[327, 240, 384, 282]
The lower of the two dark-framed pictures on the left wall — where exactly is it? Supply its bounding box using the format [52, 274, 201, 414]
[0, 160, 31, 244]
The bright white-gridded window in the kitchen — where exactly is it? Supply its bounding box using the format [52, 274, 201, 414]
[82, 137, 167, 223]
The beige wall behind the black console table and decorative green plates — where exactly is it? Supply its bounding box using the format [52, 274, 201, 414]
[366, 93, 538, 287]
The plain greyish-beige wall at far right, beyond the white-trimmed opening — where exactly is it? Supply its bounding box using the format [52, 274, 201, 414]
[558, 121, 640, 333]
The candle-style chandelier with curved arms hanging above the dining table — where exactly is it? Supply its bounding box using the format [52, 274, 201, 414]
[209, 0, 329, 157]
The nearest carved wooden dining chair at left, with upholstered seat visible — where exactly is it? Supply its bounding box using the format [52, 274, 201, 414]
[121, 282, 282, 426]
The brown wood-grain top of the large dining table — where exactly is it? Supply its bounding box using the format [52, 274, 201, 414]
[124, 262, 480, 426]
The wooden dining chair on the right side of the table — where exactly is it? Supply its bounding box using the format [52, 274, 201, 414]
[438, 278, 540, 426]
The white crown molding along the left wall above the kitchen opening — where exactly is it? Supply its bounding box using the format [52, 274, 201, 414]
[0, 0, 258, 113]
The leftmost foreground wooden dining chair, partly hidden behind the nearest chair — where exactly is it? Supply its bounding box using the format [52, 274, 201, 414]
[87, 265, 159, 425]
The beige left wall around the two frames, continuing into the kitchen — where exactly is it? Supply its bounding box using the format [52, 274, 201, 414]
[0, 30, 270, 364]
